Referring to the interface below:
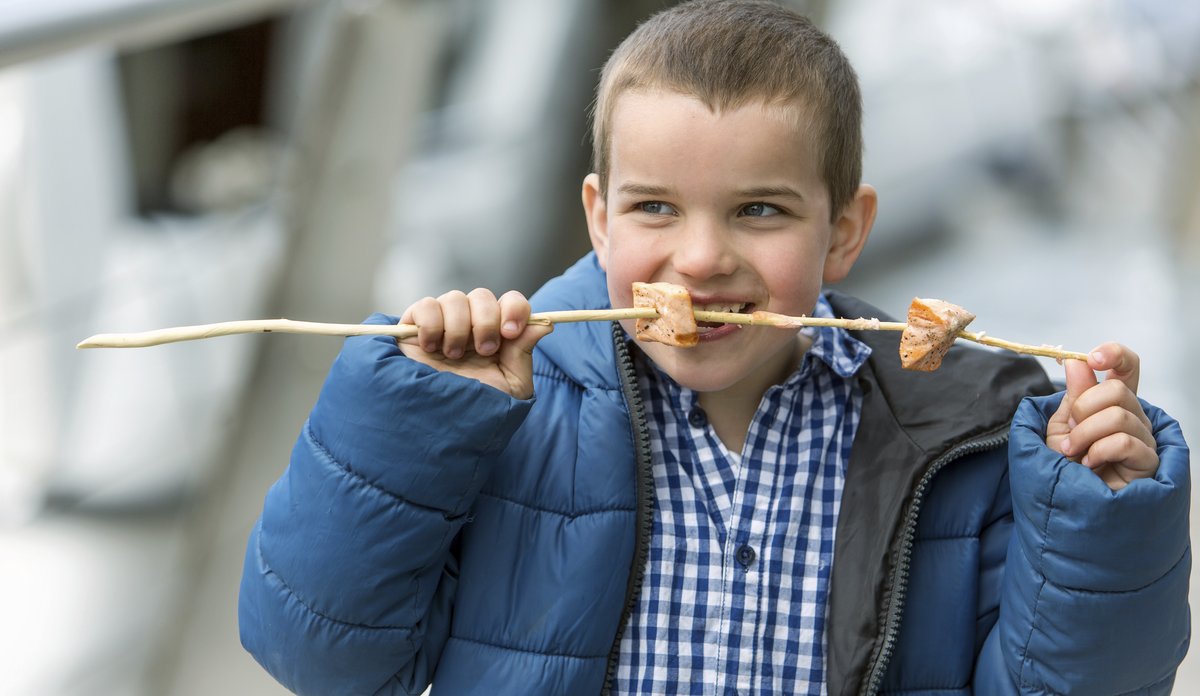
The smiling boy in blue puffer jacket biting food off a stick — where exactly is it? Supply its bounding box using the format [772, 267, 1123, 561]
[240, 1, 1190, 694]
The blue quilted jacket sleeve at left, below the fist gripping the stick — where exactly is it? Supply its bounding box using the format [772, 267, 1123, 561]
[239, 314, 529, 694]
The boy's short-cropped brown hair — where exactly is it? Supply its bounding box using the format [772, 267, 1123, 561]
[592, 0, 863, 218]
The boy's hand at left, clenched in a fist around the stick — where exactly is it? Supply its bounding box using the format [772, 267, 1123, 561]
[398, 288, 553, 398]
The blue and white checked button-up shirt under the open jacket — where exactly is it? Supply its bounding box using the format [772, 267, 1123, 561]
[614, 296, 870, 696]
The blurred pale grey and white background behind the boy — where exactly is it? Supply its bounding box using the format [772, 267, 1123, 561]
[0, 0, 1200, 696]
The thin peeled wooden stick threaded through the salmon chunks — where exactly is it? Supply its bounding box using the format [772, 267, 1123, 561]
[76, 307, 1087, 361]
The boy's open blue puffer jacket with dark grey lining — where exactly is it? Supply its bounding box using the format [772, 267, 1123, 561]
[240, 256, 1190, 696]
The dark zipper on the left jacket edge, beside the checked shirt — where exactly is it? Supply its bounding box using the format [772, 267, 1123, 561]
[600, 322, 654, 696]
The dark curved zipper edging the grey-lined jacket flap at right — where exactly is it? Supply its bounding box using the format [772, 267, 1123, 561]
[859, 426, 1008, 696]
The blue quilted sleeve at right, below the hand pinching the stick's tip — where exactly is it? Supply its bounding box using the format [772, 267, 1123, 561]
[976, 394, 1192, 695]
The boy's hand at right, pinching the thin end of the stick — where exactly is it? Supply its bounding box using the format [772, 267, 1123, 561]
[1046, 343, 1158, 491]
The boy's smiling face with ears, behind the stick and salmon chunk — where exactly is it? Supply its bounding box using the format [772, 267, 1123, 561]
[583, 91, 874, 391]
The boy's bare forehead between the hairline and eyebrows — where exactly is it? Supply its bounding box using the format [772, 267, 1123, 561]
[610, 90, 820, 193]
